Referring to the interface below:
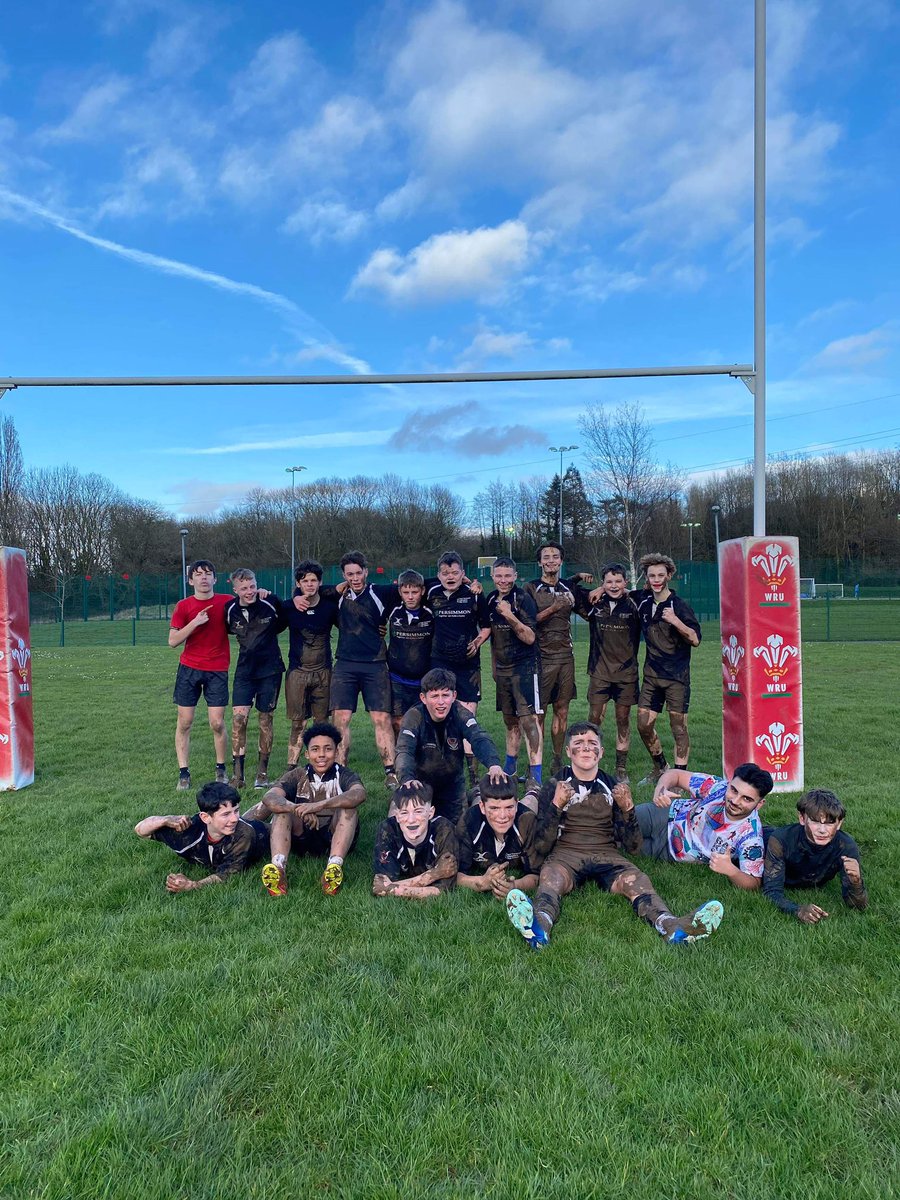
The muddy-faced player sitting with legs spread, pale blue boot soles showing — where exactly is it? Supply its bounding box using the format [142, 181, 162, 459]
[506, 721, 724, 949]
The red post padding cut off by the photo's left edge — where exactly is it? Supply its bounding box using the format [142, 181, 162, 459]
[0, 546, 35, 792]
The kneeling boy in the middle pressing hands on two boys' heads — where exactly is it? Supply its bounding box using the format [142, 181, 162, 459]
[397, 667, 506, 824]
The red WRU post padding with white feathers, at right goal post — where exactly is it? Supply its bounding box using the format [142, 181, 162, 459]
[719, 535, 803, 792]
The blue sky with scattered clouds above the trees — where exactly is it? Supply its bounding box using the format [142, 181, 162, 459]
[0, 0, 900, 515]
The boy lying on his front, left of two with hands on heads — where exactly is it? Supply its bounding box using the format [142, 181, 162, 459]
[372, 780, 458, 900]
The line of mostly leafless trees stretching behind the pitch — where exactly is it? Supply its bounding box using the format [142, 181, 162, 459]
[0, 403, 900, 599]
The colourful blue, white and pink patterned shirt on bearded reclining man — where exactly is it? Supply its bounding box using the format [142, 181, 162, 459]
[668, 775, 763, 878]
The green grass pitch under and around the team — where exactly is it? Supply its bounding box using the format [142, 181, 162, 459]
[0, 629, 900, 1200]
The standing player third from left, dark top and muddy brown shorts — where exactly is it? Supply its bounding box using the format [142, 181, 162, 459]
[283, 558, 337, 770]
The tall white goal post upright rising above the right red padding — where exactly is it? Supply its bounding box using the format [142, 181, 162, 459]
[752, 0, 766, 538]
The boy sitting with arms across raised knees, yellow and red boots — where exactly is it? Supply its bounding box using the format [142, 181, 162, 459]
[247, 721, 366, 896]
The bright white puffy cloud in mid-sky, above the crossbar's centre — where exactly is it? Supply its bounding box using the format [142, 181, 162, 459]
[350, 221, 528, 304]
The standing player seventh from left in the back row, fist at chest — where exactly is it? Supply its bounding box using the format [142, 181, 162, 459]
[487, 556, 544, 782]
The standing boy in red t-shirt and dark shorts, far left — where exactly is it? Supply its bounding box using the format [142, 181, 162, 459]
[169, 558, 234, 792]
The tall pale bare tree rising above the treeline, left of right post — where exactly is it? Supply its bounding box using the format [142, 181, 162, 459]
[578, 400, 680, 580]
